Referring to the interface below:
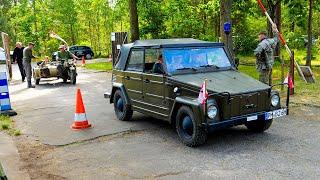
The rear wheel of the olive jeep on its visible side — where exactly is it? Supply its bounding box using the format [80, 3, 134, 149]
[113, 90, 133, 121]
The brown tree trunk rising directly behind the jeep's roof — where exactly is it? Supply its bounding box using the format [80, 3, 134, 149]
[129, 0, 139, 42]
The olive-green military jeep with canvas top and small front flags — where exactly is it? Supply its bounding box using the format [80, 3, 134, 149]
[104, 39, 289, 147]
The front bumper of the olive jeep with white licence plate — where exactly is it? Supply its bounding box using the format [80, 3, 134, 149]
[202, 108, 289, 129]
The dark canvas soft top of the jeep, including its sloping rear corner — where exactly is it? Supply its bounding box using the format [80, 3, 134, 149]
[115, 38, 224, 70]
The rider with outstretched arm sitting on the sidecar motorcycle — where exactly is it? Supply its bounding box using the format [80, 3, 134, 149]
[56, 45, 78, 77]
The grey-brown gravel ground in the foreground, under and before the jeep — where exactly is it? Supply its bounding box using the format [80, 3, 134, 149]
[18, 107, 320, 179]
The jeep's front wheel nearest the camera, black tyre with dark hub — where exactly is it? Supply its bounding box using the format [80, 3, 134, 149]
[176, 106, 207, 147]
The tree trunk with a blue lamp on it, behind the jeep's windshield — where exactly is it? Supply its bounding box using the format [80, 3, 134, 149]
[220, 0, 234, 57]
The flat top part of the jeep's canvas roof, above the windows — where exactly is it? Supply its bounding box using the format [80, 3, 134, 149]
[132, 38, 223, 48]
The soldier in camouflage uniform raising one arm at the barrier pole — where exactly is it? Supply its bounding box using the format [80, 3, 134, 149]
[254, 25, 279, 86]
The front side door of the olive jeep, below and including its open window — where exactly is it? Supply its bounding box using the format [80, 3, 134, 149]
[143, 49, 169, 119]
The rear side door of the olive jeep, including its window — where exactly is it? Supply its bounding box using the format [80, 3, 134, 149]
[124, 49, 144, 108]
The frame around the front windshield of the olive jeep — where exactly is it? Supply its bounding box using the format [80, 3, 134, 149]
[162, 46, 235, 75]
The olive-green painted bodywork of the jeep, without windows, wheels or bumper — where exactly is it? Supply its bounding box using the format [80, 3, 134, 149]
[110, 38, 282, 125]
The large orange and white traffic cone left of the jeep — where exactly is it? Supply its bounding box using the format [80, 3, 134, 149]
[71, 89, 91, 130]
